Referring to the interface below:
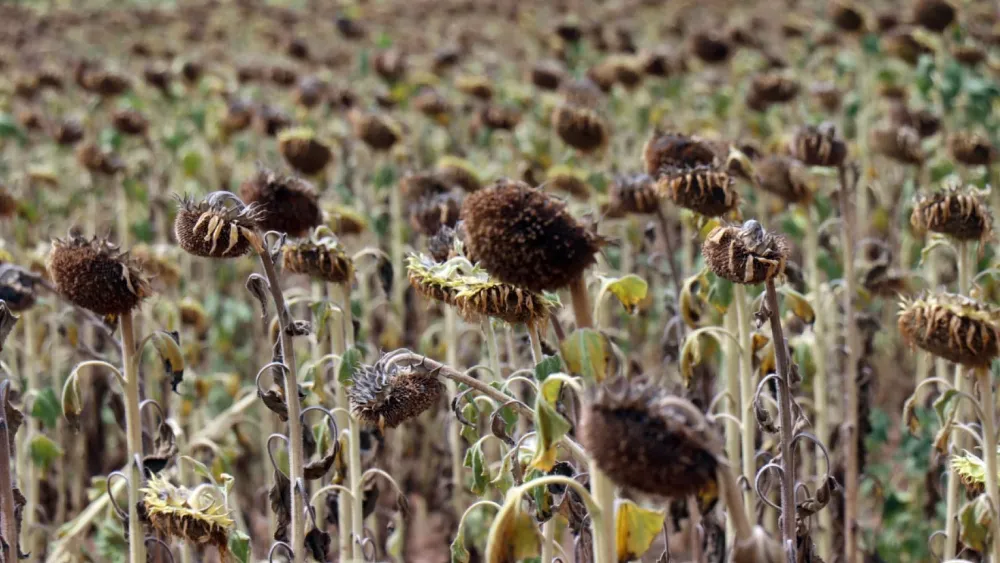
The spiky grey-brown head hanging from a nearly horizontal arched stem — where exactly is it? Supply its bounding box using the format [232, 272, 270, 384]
[347, 356, 444, 430]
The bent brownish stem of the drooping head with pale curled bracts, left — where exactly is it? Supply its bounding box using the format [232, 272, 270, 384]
[258, 247, 305, 563]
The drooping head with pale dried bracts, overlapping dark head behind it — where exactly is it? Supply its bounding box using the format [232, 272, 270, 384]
[174, 193, 261, 258]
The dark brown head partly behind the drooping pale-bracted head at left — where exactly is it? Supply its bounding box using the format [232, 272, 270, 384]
[240, 167, 322, 237]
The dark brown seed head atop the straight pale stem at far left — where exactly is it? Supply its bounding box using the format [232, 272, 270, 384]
[46, 233, 152, 315]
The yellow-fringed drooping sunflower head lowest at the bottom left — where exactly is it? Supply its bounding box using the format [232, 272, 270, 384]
[141, 475, 235, 556]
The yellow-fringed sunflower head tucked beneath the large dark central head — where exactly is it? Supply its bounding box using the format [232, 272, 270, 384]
[407, 254, 559, 326]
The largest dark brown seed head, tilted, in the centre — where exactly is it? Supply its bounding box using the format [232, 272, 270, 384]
[461, 180, 602, 292]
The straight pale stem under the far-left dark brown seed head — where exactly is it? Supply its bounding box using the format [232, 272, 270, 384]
[120, 311, 146, 561]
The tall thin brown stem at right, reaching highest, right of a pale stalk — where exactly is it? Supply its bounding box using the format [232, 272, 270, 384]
[837, 165, 861, 563]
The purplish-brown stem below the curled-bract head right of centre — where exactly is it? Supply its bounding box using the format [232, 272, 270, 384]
[765, 279, 796, 561]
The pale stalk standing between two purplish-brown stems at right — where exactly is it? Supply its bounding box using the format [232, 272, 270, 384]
[805, 206, 833, 561]
